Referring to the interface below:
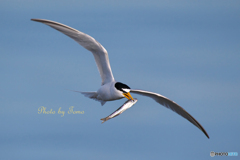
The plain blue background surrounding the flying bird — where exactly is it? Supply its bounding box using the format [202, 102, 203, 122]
[0, 0, 240, 160]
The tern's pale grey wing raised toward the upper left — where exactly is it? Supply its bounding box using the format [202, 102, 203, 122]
[31, 19, 114, 85]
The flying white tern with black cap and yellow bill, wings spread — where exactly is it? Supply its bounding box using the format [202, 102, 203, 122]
[31, 19, 209, 138]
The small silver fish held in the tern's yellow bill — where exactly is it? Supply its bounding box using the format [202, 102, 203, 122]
[101, 98, 138, 123]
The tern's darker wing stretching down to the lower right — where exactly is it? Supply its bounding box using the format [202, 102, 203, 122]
[130, 89, 209, 138]
